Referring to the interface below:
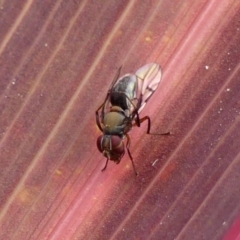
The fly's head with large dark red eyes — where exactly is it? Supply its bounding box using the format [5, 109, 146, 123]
[97, 135, 125, 164]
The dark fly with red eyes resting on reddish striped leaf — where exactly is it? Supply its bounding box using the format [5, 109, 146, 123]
[96, 63, 170, 175]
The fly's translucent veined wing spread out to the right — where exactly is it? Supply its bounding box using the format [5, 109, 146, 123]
[135, 63, 162, 113]
